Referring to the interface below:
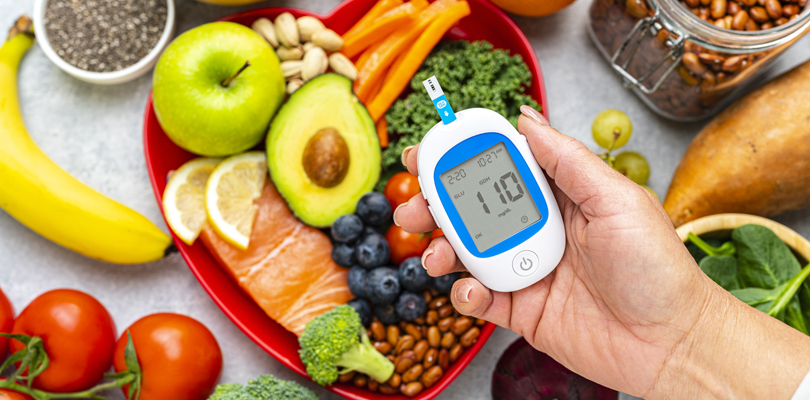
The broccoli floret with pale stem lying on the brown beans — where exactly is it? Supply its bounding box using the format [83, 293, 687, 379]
[298, 305, 394, 386]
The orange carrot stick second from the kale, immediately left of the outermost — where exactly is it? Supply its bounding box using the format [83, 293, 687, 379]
[354, 0, 458, 101]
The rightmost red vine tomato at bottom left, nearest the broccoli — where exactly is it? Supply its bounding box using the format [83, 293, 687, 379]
[113, 313, 222, 400]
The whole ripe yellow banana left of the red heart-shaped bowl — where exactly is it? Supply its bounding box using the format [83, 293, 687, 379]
[0, 17, 171, 264]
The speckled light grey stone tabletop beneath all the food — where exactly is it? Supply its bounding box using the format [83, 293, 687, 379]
[0, 0, 810, 400]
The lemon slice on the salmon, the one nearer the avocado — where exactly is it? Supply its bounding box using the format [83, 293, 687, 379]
[205, 151, 267, 250]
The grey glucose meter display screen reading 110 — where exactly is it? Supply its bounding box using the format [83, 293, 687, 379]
[441, 142, 543, 253]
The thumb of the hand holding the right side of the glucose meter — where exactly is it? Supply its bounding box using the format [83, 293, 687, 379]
[518, 106, 640, 215]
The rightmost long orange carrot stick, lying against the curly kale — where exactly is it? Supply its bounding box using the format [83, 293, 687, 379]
[366, 1, 470, 121]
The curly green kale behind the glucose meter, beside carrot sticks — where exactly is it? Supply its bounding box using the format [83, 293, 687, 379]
[382, 41, 540, 174]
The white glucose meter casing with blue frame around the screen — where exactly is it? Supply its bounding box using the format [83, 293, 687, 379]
[417, 108, 566, 292]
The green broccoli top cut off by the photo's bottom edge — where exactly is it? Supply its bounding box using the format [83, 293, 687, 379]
[208, 375, 318, 400]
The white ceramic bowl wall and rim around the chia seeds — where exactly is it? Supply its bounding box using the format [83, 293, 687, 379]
[34, 0, 175, 85]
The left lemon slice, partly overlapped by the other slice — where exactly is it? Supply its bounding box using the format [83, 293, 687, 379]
[163, 158, 222, 245]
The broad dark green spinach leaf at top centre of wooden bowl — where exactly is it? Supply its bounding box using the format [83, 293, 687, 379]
[731, 224, 801, 289]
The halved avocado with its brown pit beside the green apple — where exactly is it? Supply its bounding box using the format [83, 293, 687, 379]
[267, 74, 380, 228]
